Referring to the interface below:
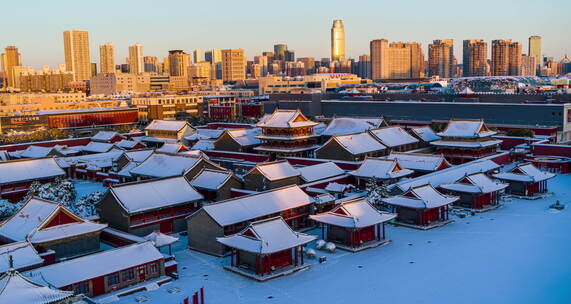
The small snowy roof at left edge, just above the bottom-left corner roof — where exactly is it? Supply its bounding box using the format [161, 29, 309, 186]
[0, 241, 44, 274]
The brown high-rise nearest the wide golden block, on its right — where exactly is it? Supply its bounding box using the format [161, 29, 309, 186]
[428, 39, 456, 78]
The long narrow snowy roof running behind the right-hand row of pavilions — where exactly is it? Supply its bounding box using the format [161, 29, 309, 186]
[389, 159, 500, 191]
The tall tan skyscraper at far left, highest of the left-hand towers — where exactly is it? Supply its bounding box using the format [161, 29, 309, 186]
[63, 30, 91, 81]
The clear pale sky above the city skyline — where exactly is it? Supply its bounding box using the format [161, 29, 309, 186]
[0, 0, 571, 66]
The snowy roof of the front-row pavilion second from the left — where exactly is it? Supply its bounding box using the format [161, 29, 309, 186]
[309, 198, 396, 228]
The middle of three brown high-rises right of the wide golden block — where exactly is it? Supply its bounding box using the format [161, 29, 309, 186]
[462, 39, 488, 77]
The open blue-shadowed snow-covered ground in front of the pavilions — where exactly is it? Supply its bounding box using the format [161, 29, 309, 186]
[111, 175, 571, 304]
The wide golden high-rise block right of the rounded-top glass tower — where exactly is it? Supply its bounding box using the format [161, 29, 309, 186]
[370, 39, 424, 80]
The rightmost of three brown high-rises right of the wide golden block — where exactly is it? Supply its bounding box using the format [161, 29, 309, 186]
[491, 40, 521, 76]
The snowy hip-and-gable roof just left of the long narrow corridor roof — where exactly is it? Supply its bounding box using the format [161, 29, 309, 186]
[349, 157, 413, 179]
